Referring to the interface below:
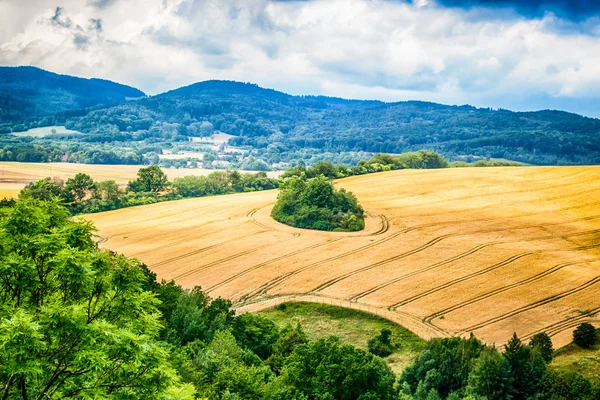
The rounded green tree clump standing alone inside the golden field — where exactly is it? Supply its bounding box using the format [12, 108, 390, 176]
[271, 175, 365, 232]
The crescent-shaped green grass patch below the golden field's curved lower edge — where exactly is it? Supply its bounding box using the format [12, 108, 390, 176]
[259, 302, 425, 375]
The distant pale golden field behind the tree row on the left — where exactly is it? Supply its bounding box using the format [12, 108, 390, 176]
[0, 162, 279, 199]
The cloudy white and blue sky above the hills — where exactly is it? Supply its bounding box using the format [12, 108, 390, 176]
[0, 0, 600, 117]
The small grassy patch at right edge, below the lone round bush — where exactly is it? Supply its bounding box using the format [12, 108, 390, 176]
[550, 343, 600, 380]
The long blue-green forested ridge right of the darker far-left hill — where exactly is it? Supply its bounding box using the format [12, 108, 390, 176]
[61, 81, 600, 164]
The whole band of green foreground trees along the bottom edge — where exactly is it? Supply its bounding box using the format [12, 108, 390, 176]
[0, 198, 600, 400]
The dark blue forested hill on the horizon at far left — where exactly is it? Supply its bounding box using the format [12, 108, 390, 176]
[0, 67, 145, 122]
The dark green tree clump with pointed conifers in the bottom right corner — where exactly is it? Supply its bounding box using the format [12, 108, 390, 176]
[399, 333, 600, 400]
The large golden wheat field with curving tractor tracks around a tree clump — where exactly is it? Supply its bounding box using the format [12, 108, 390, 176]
[87, 167, 600, 347]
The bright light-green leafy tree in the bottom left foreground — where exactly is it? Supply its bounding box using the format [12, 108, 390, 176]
[0, 199, 190, 399]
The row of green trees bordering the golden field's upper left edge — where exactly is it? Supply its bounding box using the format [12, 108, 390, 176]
[20, 166, 279, 214]
